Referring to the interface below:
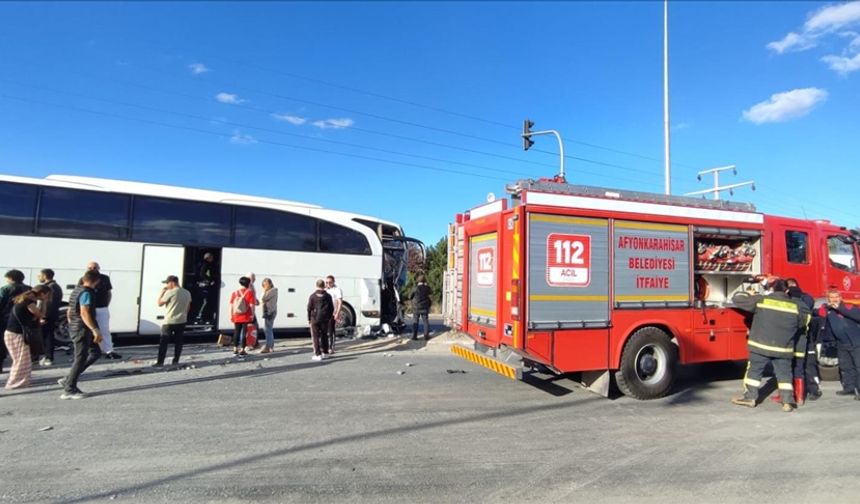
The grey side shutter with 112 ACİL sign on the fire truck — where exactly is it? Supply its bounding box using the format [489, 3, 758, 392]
[526, 214, 609, 330]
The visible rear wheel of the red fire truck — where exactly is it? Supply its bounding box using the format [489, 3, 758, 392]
[615, 327, 678, 399]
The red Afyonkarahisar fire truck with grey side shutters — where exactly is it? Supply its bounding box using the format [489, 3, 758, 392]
[444, 178, 860, 399]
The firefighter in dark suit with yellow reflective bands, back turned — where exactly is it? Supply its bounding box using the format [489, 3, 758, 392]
[732, 279, 811, 412]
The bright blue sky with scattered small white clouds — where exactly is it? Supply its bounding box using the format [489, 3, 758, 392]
[0, 2, 860, 243]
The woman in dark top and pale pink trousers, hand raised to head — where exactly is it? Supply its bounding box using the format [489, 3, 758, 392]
[3, 285, 51, 389]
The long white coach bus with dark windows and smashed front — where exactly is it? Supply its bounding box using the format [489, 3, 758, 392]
[0, 175, 424, 335]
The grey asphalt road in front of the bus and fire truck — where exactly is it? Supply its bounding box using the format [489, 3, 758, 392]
[0, 322, 860, 503]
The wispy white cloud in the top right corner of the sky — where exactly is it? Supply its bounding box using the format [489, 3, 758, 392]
[767, 1, 860, 54]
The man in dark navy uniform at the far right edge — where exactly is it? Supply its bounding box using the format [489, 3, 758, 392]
[819, 287, 860, 401]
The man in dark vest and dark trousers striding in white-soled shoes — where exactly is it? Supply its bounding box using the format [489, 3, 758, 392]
[57, 269, 102, 399]
